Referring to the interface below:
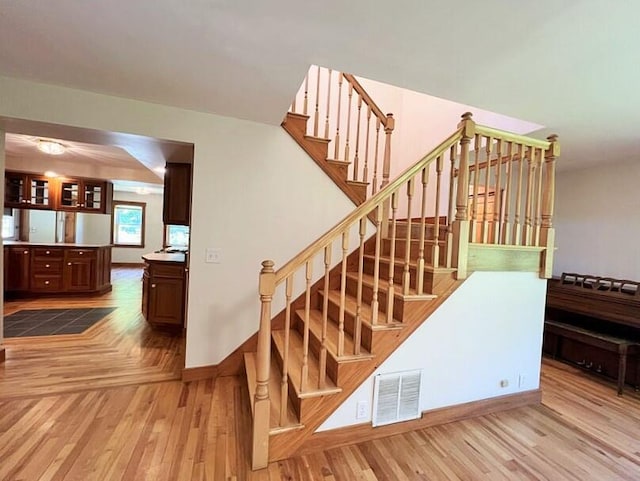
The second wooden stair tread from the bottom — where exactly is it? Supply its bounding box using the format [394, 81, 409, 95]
[272, 329, 342, 399]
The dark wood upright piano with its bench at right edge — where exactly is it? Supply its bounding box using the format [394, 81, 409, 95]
[543, 273, 640, 394]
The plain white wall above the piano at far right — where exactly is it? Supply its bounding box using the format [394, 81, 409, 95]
[553, 158, 640, 280]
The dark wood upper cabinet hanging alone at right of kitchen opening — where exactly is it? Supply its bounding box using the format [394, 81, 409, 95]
[162, 163, 191, 225]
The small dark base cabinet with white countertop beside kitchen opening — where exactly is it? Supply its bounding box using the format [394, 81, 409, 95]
[142, 252, 186, 327]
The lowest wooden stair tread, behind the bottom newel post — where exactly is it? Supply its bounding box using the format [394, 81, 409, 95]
[244, 352, 304, 434]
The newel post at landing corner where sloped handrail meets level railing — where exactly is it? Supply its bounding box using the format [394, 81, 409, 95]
[452, 112, 476, 279]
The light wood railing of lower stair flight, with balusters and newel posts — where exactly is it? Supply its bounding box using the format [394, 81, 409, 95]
[252, 113, 559, 469]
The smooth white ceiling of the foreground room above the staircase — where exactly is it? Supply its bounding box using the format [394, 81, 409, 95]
[0, 0, 640, 168]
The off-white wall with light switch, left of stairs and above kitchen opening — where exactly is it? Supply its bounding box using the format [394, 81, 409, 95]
[0, 77, 360, 367]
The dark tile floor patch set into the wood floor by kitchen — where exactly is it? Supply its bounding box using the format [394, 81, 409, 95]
[4, 307, 116, 337]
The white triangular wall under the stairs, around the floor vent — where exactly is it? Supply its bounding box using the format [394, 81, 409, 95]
[318, 272, 546, 431]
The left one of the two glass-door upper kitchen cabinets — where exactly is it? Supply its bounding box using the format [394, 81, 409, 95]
[4, 171, 56, 210]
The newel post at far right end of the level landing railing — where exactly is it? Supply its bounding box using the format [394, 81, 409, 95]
[540, 134, 560, 279]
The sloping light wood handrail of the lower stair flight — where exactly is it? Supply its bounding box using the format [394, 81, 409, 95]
[275, 128, 463, 285]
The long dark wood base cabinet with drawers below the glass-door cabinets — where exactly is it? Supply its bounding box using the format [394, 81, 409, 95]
[4, 242, 111, 297]
